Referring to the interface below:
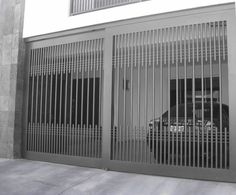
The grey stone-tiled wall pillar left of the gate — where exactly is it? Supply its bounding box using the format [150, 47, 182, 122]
[0, 0, 24, 158]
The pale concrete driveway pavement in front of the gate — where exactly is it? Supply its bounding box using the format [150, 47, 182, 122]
[0, 159, 236, 195]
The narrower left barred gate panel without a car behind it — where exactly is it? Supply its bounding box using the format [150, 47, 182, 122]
[26, 38, 104, 163]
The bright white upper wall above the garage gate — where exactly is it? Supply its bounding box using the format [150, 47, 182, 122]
[23, 0, 235, 38]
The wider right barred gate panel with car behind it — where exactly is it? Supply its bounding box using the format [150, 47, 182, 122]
[111, 21, 230, 170]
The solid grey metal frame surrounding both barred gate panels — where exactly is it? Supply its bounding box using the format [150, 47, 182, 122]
[23, 3, 236, 182]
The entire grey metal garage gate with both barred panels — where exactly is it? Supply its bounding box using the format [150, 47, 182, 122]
[25, 4, 235, 181]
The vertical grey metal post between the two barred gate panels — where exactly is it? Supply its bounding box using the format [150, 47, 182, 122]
[101, 31, 112, 169]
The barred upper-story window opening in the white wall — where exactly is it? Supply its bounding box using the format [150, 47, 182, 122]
[70, 0, 147, 15]
